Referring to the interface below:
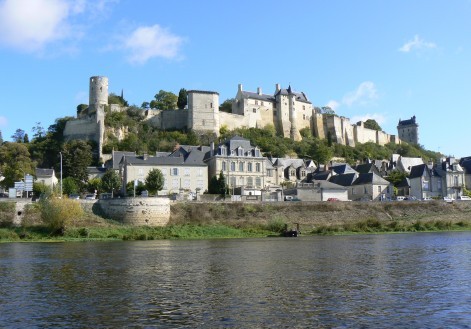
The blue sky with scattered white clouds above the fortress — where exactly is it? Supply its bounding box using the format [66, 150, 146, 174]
[0, 0, 471, 157]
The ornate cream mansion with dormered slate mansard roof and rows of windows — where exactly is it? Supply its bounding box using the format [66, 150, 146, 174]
[204, 136, 268, 190]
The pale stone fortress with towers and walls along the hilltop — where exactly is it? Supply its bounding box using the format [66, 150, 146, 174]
[64, 76, 408, 158]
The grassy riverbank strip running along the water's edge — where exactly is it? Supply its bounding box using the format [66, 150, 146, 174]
[0, 197, 471, 242]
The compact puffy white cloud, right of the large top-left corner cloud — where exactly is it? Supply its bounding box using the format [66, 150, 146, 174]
[124, 25, 183, 64]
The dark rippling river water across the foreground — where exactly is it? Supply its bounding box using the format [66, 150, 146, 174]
[0, 232, 471, 328]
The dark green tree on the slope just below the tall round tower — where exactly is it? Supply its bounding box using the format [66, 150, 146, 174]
[62, 140, 93, 189]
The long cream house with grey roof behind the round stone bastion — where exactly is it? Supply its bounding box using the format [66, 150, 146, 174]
[119, 146, 208, 195]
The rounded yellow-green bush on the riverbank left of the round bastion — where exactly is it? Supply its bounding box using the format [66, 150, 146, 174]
[41, 198, 83, 233]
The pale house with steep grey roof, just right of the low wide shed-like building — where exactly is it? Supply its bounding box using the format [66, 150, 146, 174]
[349, 173, 393, 201]
